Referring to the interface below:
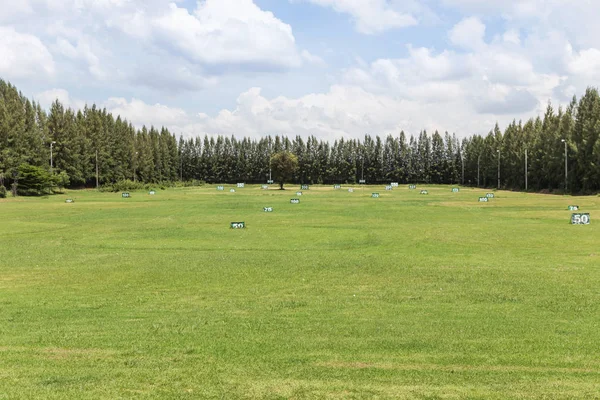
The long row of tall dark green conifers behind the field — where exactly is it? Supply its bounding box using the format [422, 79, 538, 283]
[0, 80, 600, 193]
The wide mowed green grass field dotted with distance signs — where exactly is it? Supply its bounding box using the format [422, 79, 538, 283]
[0, 185, 600, 399]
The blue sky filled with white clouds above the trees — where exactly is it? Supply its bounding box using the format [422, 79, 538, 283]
[0, 0, 600, 140]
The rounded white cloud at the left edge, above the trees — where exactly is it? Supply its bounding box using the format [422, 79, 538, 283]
[0, 26, 55, 79]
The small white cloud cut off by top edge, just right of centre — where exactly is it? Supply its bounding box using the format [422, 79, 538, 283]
[305, 0, 417, 34]
